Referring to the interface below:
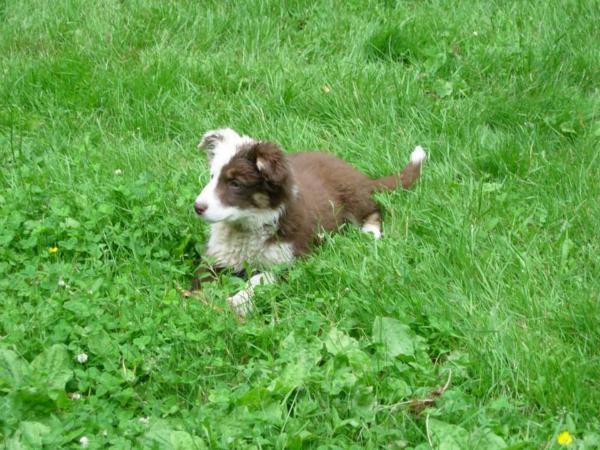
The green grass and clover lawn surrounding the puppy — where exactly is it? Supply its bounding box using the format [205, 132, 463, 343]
[0, 0, 600, 449]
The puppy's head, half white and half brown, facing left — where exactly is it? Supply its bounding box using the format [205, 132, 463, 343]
[194, 130, 292, 223]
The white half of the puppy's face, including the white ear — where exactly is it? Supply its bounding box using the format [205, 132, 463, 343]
[196, 128, 252, 222]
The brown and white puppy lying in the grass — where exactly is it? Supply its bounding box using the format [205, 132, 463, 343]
[194, 128, 426, 317]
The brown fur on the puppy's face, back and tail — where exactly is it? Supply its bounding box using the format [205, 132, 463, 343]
[209, 142, 421, 255]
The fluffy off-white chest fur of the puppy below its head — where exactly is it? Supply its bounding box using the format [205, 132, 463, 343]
[206, 223, 294, 271]
